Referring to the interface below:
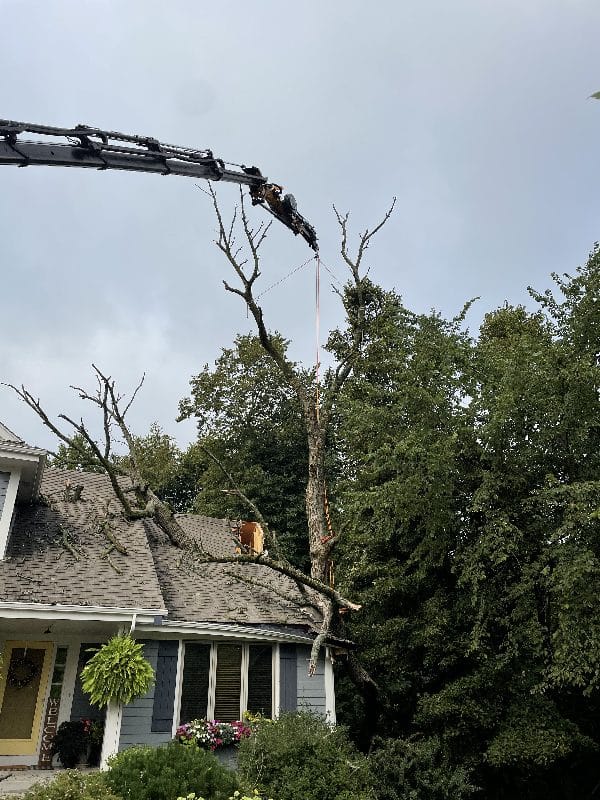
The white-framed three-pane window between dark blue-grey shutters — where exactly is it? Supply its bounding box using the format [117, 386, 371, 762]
[178, 641, 278, 724]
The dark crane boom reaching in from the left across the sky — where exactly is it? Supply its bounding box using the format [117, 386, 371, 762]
[0, 120, 318, 251]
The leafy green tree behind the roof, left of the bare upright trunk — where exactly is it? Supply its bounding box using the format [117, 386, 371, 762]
[180, 335, 309, 567]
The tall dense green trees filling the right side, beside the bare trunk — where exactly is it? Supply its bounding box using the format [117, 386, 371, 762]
[338, 246, 600, 800]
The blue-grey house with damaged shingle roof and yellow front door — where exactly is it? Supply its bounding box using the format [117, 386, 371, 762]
[0, 424, 335, 768]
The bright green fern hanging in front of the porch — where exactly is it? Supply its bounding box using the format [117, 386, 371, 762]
[81, 634, 154, 708]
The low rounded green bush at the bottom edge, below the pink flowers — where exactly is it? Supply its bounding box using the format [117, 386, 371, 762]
[106, 742, 238, 800]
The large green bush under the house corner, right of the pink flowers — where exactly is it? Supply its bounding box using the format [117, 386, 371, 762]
[238, 712, 375, 800]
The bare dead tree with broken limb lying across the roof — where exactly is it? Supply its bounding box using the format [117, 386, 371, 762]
[6, 194, 395, 683]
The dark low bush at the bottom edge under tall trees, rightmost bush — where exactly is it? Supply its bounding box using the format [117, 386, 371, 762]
[369, 737, 475, 800]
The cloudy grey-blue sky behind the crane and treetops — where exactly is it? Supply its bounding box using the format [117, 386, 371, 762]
[0, 0, 600, 448]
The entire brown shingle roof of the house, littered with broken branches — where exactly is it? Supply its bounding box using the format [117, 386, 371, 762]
[0, 468, 320, 630]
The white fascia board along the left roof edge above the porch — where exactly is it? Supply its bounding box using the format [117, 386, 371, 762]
[0, 602, 168, 627]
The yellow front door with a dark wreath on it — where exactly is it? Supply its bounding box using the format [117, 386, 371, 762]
[0, 642, 54, 756]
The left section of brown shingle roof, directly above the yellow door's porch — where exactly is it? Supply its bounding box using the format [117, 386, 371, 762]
[0, 468, 164, 610]
